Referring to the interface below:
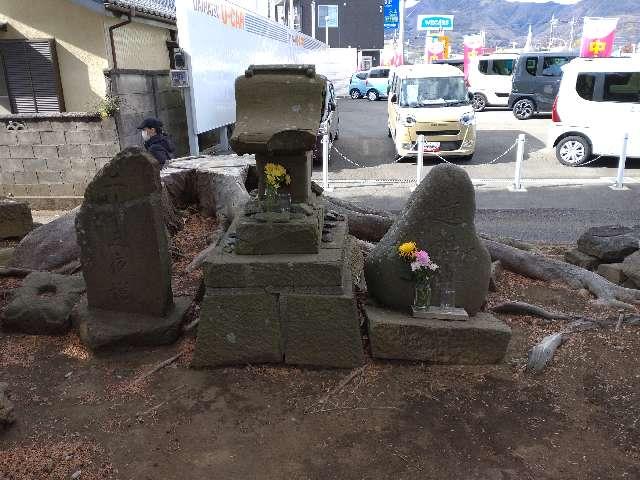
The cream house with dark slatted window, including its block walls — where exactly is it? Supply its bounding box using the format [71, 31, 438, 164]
[0, 0, 187, 197]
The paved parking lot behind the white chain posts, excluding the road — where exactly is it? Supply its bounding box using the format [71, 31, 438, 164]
[315, 98, 640, 184]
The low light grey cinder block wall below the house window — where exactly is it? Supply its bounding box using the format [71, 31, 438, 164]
[0, 113, 120, 197]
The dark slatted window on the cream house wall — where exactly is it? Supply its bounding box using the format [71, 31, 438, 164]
[0, 40, 64, 113]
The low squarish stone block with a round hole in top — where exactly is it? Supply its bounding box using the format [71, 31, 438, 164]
[2, 272, 85, 335]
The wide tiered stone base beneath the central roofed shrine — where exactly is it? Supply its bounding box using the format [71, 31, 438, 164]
[193, 217, 364, 368]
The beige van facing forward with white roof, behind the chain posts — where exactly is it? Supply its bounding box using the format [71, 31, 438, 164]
[388, 65, 476, 160]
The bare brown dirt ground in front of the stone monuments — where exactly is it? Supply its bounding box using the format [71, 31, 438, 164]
[0, 216, 640, 480]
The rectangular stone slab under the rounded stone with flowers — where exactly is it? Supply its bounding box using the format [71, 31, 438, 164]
[366, 306, 511, 365]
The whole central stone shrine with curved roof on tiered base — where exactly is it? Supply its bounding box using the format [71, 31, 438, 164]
[193, 65, 364, 368]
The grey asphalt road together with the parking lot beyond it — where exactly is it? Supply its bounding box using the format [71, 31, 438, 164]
[314, 99, 640, 243]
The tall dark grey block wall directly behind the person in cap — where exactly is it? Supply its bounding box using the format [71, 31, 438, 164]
[109, 70, 189, 157]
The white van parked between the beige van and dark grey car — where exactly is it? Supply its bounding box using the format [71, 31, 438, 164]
[467, 53, 518, 112]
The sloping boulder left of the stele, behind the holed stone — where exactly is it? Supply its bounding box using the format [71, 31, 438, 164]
[9, 208, 80, 273]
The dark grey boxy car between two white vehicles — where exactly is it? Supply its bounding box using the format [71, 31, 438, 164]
[508, 52, 576, 120]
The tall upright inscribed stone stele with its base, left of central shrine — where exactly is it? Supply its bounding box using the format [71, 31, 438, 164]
[75, 147, 190, 348]
